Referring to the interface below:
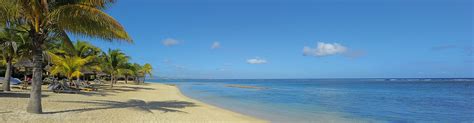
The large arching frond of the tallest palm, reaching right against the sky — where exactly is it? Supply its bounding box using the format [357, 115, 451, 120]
[50, 4, 132, 42]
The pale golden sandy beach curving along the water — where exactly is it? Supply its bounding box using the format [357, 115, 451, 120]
[0, 83, 267, 123]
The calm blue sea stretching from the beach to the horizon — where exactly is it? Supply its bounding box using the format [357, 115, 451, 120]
[150, 79, 474, 122]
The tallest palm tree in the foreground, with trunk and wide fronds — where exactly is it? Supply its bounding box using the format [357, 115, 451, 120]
[0, 0, 131, 113]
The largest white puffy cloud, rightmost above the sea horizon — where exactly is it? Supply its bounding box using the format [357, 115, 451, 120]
[303, 42, 347, 57]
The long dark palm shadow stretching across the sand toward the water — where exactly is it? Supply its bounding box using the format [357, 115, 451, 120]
[46, 99, 197, 114]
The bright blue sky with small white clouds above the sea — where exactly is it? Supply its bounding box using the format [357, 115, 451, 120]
[72, 0, 474, 78]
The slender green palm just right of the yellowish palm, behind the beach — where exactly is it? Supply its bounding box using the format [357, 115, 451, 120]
[102, 49, 129, 87]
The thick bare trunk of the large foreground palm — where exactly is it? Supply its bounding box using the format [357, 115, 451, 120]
[26, 45, 44, 114]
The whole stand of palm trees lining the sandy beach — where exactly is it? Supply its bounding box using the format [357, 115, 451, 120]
[0, 0, 152, 113]
